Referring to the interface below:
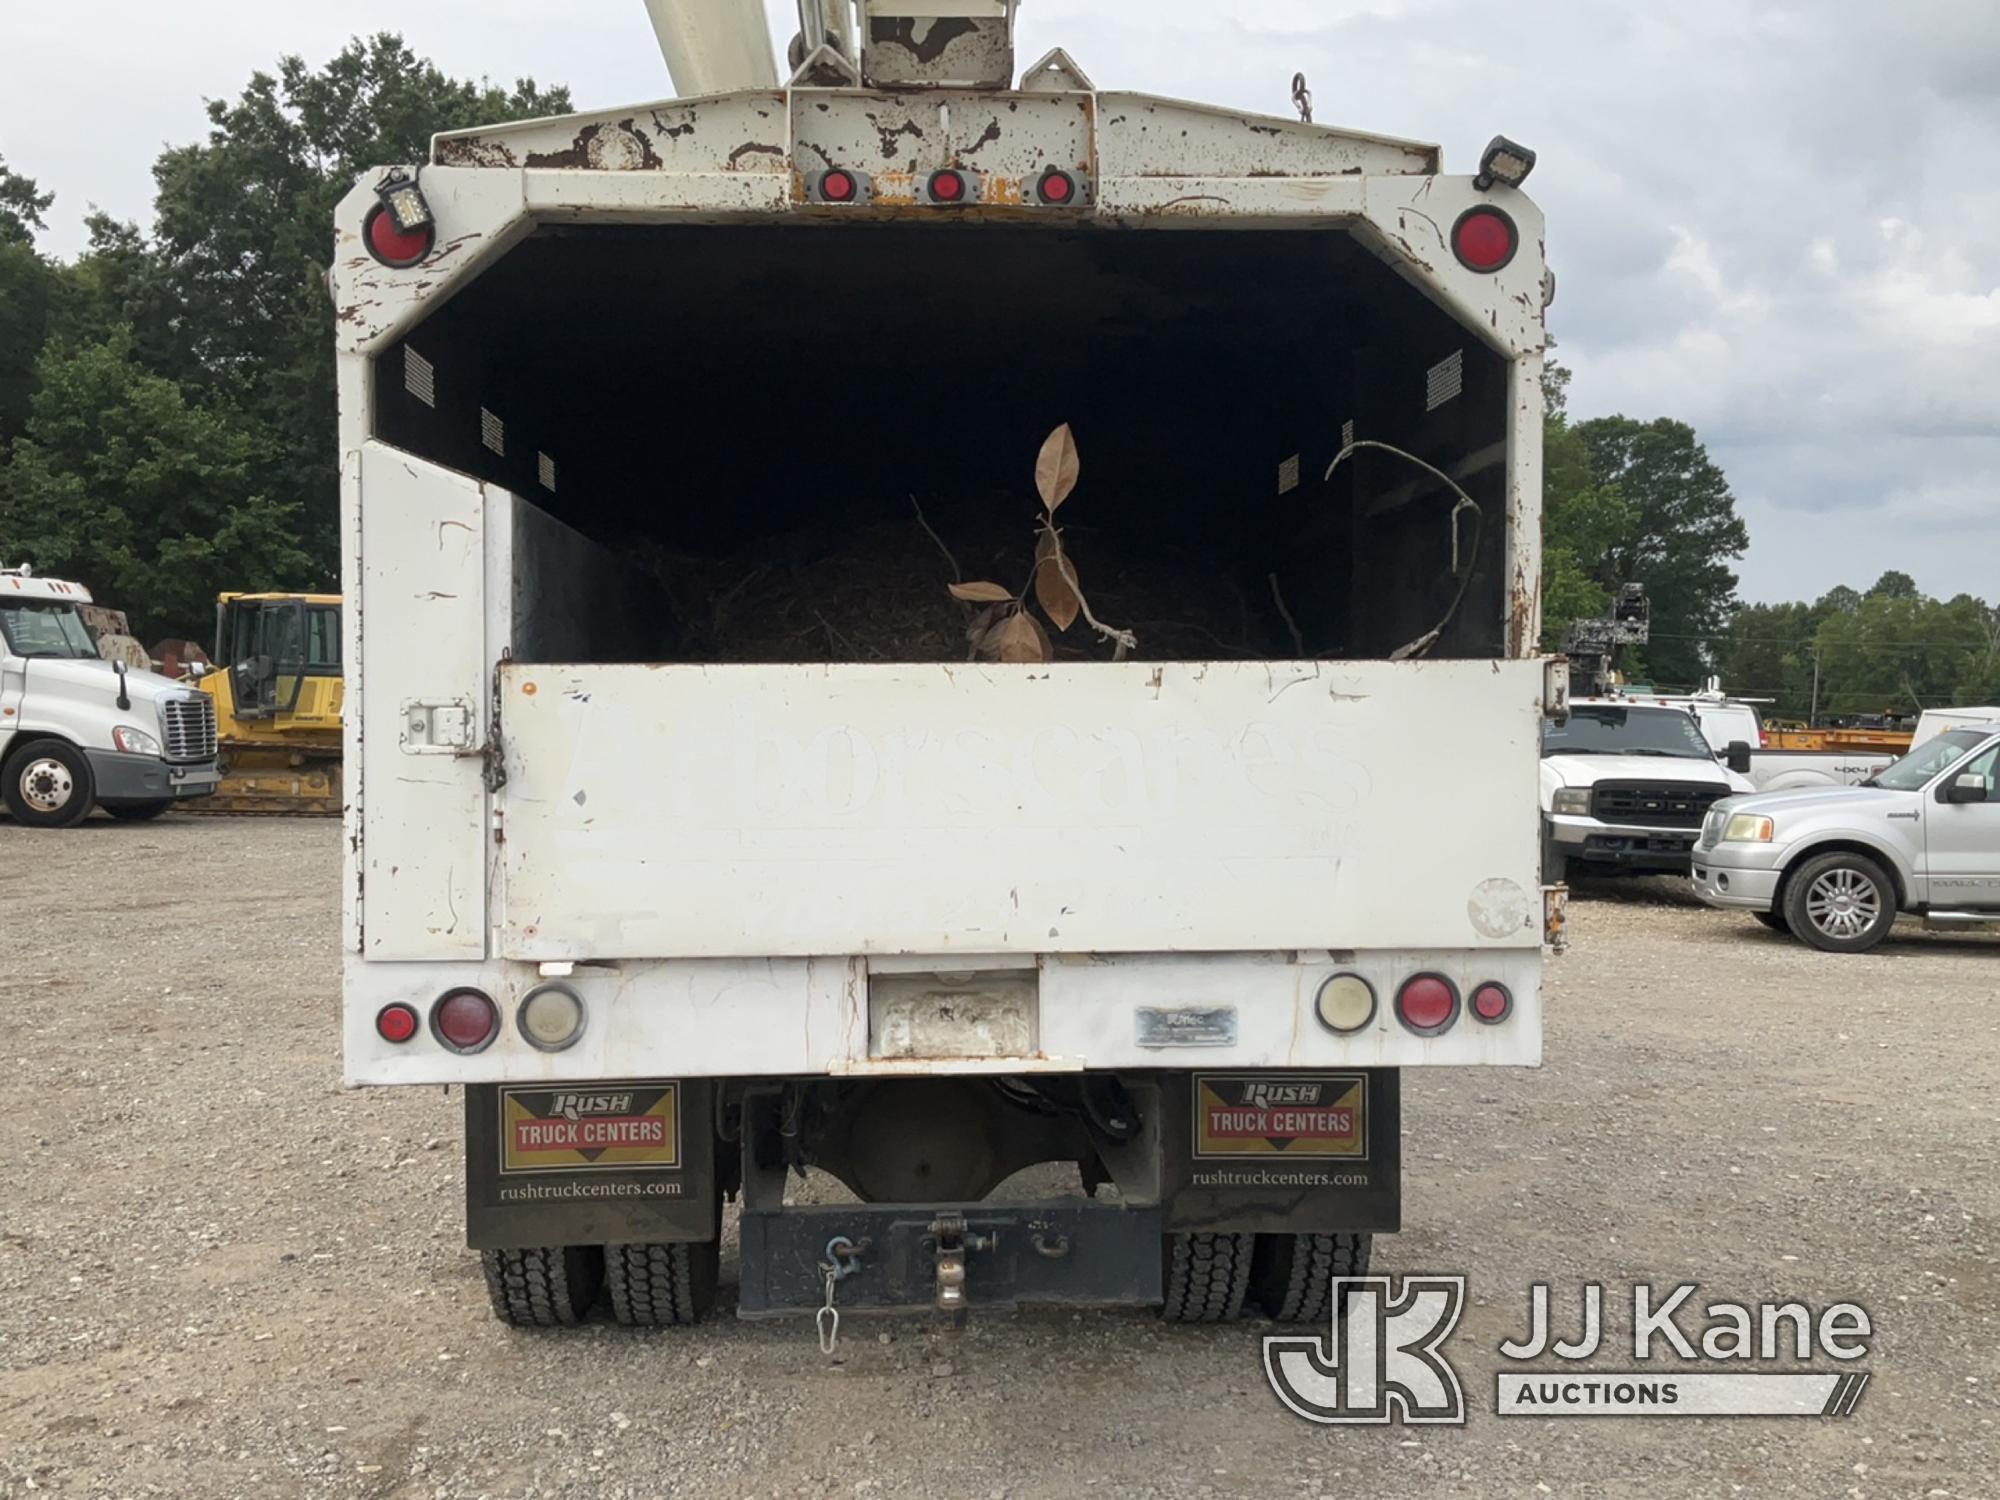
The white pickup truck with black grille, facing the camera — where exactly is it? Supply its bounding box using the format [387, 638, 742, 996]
[1542, 698, 1756, 884]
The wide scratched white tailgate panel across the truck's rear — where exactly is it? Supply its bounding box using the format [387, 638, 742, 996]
[500, 662, 1542, 960]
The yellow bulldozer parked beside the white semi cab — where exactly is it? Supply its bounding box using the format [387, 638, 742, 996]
[188, 594, 342, 816]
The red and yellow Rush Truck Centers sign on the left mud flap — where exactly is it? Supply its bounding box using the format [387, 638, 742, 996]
[500, 1082, 680, 1174]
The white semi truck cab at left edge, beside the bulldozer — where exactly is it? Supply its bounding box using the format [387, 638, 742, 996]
[0, 568, 220, 828]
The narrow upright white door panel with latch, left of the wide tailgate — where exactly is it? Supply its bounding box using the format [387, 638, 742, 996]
[360, 442, 486, 958]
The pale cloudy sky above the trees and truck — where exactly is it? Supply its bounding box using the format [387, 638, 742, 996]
[0, 0, 2000, 600]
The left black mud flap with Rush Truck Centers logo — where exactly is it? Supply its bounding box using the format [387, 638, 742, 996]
[466, 1078, 718, 1250]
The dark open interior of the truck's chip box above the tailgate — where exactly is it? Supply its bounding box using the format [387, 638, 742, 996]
[372, 216, 1508, 662]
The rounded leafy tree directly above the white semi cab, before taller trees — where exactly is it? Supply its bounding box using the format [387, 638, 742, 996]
[0, 330, 310, 636]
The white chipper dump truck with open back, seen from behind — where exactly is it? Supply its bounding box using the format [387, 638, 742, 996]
[332, 0, 1566, 1332]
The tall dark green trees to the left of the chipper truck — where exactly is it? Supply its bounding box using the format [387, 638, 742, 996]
[0, 34, 570, 640]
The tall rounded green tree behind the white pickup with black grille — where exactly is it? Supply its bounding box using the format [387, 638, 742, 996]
[1576, 416, 1750, 684]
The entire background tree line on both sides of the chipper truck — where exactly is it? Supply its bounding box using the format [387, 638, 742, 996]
[0, 34, 2000, 718]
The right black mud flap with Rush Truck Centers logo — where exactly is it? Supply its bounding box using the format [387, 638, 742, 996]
[1160, 1068, 1402, 1234]
